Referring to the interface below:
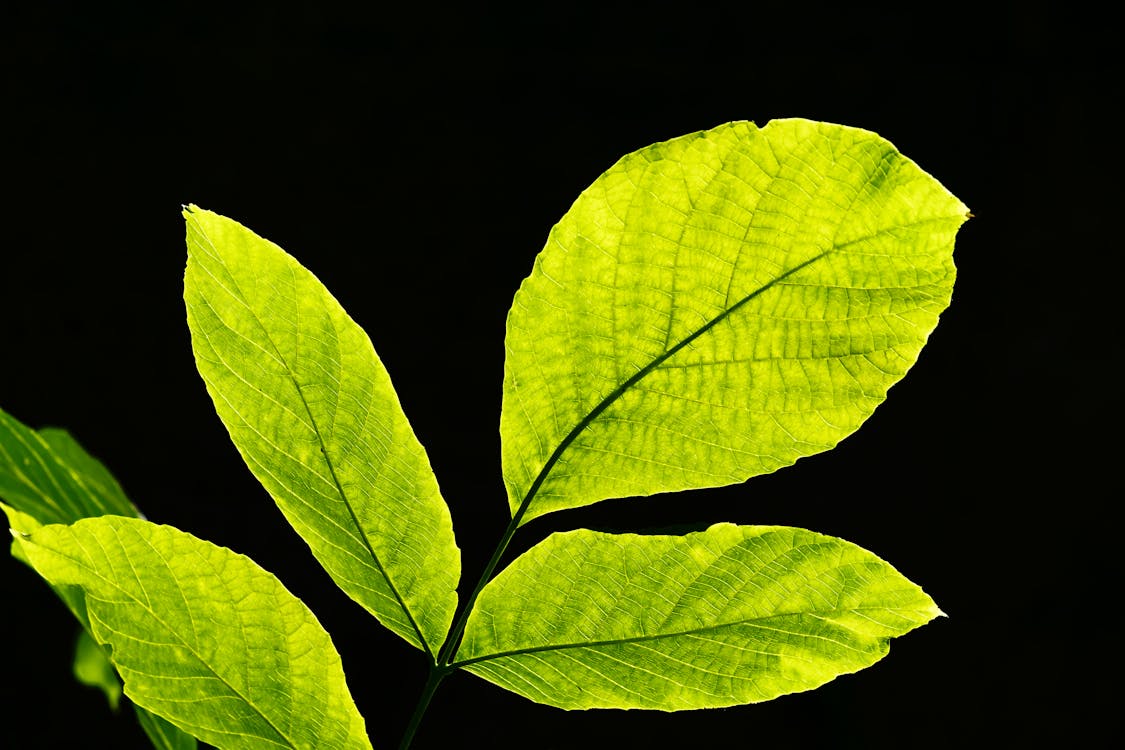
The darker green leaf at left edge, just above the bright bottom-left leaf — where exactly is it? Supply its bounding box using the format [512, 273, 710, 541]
[0, 409, 137, 524]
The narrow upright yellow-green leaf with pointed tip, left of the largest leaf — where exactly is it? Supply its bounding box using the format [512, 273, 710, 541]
[185, 206, 460, 658]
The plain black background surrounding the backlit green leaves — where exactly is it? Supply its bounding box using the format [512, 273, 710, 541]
[0, 2, 1107, 748]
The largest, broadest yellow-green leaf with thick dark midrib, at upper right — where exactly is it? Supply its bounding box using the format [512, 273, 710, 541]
[501, 120, 966, 522]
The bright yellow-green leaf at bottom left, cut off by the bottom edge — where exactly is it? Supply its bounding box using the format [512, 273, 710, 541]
[21, 516, 370, 748]
